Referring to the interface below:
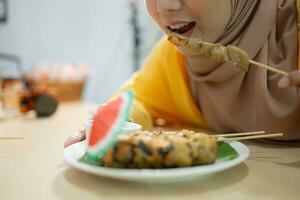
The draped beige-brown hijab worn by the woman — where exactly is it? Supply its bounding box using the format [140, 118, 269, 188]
[187, 0, 300, 140]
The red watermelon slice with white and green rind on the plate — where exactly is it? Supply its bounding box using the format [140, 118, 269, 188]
[87, 91, 133, 160]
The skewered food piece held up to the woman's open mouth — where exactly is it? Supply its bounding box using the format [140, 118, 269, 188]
[168, 33, 249, 71]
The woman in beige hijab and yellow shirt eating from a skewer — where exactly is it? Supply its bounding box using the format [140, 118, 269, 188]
[66, 0, 300, 145]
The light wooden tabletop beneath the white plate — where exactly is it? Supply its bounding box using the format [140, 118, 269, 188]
[0, 102, 300, 200]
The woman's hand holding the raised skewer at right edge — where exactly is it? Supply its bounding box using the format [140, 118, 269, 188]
[278, 70, 300, 97]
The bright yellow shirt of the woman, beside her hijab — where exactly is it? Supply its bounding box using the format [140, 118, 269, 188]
[116, 38, 207, 129]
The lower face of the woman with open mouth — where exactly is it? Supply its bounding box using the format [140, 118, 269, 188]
[145, 0, 231, 42]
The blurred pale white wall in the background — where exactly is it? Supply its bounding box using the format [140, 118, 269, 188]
[0, 0, 162, 103]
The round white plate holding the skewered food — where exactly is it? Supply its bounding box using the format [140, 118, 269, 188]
[64, 139, 249, 183]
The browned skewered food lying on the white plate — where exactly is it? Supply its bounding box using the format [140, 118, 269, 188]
[101, 130, 218, 169]
